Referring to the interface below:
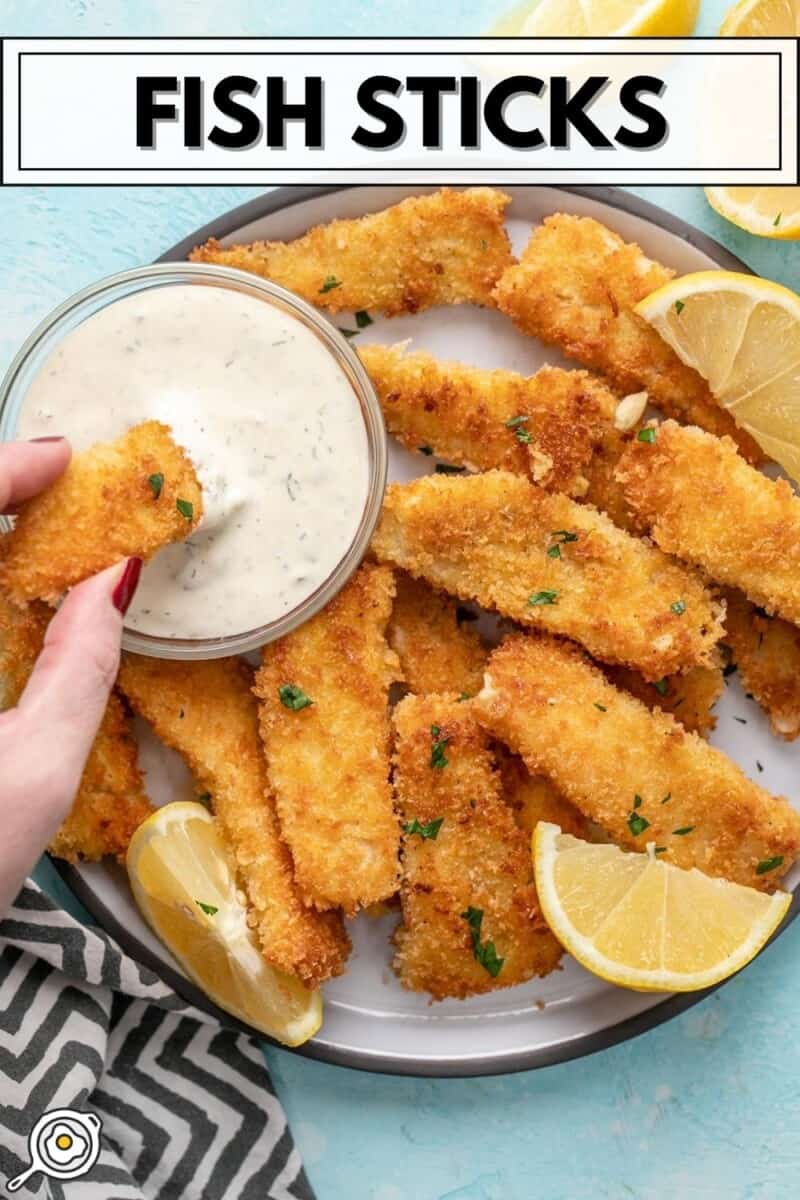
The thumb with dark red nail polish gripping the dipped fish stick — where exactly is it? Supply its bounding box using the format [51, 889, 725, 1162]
[17, 558, 142, 799]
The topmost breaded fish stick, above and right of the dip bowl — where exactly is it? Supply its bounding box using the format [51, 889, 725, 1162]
[190, 187, 513, 317]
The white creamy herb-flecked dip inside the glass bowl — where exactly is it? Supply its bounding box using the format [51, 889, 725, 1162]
[18, 284, 369, 638]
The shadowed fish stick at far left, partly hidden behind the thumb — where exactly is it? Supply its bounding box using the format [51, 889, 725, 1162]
[0, 595, 152, 863]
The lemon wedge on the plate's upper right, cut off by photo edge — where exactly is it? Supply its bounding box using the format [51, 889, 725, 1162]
[636, 271, 800, 480]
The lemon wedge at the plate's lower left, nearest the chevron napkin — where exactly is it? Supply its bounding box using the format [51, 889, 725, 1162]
[127, 800, 323, 1046]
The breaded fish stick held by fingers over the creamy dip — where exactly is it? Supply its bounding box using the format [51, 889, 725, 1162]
[0, 421, 203, 604]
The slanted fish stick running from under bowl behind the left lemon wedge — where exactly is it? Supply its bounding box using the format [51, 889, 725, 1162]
[120, 654, 350, 988]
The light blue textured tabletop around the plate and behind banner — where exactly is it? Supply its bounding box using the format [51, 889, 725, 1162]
[0, 0, 800, 1200]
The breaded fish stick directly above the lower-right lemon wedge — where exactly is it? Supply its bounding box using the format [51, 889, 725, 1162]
[470, 635, 800, 889]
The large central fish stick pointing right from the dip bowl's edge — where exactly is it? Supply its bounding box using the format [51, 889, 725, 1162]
[372, 470, 722, 679]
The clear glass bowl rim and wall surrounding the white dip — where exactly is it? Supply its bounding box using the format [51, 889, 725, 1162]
[0, 263, 387, 660]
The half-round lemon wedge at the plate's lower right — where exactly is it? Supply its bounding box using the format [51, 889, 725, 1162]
[534, 821, 792, 991]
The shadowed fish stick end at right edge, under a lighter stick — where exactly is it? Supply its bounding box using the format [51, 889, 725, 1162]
[724, 588, 800, 742]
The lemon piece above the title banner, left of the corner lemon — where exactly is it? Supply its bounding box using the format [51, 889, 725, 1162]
[506, 0, 699, 37]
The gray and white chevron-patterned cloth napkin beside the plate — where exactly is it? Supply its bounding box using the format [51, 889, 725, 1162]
[0, 881, 314, 1200]
